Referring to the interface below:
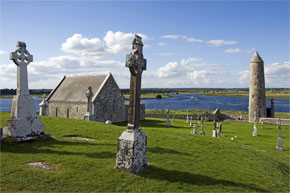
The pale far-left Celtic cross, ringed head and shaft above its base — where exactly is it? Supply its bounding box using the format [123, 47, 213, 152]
[10, 41, 33, 95]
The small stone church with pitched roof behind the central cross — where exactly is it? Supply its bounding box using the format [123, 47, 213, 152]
[40, 73, 145, 122]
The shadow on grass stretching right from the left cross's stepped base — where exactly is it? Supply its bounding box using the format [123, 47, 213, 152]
[1, 138, 116, 159]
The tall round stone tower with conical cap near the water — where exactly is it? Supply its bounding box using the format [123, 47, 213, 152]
[249, 52, 266, 122]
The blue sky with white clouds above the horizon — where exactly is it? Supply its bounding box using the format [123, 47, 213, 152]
[0, 0, 290, 89]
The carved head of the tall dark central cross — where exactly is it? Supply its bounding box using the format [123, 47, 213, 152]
[126, 34, 147, 75]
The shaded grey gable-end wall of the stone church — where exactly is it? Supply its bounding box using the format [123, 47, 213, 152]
[93, 76, 127, 122]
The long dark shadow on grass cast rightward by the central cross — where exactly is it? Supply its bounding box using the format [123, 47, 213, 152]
[140, 166, 267, 192]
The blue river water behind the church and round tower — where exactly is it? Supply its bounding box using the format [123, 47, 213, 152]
[0, 94, 290, 112]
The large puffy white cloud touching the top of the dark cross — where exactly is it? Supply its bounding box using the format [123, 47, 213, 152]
[61, 31, 148, 58]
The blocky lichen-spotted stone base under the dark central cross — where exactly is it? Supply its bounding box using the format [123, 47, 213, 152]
[116, 129, 147, 174]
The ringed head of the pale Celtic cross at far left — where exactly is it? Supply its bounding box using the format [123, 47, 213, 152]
[10, 41, 33, 66]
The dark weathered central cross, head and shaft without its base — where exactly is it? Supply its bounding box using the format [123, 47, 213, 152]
[126, 34, 146, 130]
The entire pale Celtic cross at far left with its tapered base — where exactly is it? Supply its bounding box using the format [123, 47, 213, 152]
[4, 42, 50, 142]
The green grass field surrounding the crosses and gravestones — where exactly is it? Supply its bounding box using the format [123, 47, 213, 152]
[0, 113, 290, 192]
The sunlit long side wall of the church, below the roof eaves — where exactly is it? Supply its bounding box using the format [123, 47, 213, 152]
[47, 101, 87, 119]
